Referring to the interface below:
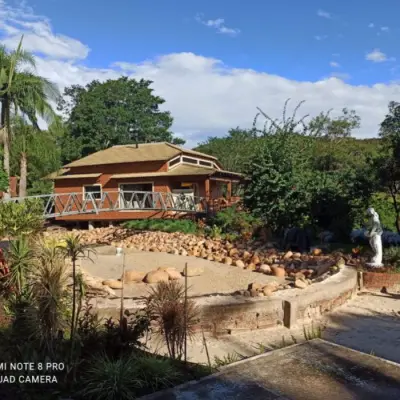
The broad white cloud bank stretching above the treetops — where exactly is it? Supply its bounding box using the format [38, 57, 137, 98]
[0, 0, 400, 147]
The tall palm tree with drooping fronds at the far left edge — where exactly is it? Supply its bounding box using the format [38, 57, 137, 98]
[0, 37, 59, 197]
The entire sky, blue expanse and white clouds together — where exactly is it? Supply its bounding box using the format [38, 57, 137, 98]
[0, 0, 400, 147]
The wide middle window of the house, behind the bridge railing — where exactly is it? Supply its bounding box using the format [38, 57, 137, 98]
[119, 183, 154, 209]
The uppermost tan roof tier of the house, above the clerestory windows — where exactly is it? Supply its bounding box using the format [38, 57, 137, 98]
[65, 142, 217, 168]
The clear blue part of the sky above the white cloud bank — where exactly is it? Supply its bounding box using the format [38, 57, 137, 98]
[29, 0, 400, 84]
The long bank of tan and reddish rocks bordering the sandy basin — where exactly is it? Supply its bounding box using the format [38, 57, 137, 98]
[53, 227, 347, 294]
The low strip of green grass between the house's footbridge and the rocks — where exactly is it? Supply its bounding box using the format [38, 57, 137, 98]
[123, 219, 198, 234]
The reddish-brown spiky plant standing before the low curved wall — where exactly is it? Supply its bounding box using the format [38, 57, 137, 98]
[147, 281, 199, 359]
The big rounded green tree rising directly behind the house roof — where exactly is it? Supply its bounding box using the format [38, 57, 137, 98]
[59, 77, 183, 162]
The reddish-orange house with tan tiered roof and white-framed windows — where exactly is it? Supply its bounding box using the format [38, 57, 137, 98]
[50, 142, 244, 222]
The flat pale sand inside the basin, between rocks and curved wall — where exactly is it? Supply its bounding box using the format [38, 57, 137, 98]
[81, 248, 284, 298]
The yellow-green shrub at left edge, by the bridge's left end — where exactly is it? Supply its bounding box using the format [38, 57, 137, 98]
[0, 199, 44, 237]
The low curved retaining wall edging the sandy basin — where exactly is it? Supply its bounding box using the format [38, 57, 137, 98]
[93, 267, 358, 335]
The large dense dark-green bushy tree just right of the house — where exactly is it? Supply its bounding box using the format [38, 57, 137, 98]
[244, 103, 372, 236]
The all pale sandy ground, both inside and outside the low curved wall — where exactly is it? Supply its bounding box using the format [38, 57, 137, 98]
[82, 248, 400, 363]
